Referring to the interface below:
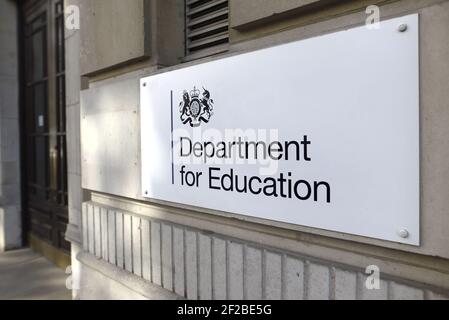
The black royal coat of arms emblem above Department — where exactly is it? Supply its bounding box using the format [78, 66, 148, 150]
[179, 87, 214, 127]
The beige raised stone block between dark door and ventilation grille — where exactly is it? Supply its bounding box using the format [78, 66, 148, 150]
[80, 0, 151, 75]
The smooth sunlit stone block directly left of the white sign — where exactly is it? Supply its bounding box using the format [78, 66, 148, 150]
[81, 74, 141, 198]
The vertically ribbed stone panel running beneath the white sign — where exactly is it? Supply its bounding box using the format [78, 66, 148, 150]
[82, 202, 449, 300]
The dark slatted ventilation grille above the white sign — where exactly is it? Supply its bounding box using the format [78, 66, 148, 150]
[185, 0, 229, 55]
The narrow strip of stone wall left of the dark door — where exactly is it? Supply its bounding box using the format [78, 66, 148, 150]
[0, 0, 22, 252]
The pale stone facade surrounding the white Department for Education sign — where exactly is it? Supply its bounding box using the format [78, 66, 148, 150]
[67, 0, 449, 300]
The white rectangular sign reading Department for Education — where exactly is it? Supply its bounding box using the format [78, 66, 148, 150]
[141, 15, 420, 245]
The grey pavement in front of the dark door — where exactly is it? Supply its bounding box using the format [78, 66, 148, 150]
[0, 249, 72, 300]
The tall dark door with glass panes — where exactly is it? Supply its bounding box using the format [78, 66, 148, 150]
[22, 0, 70, 255]
